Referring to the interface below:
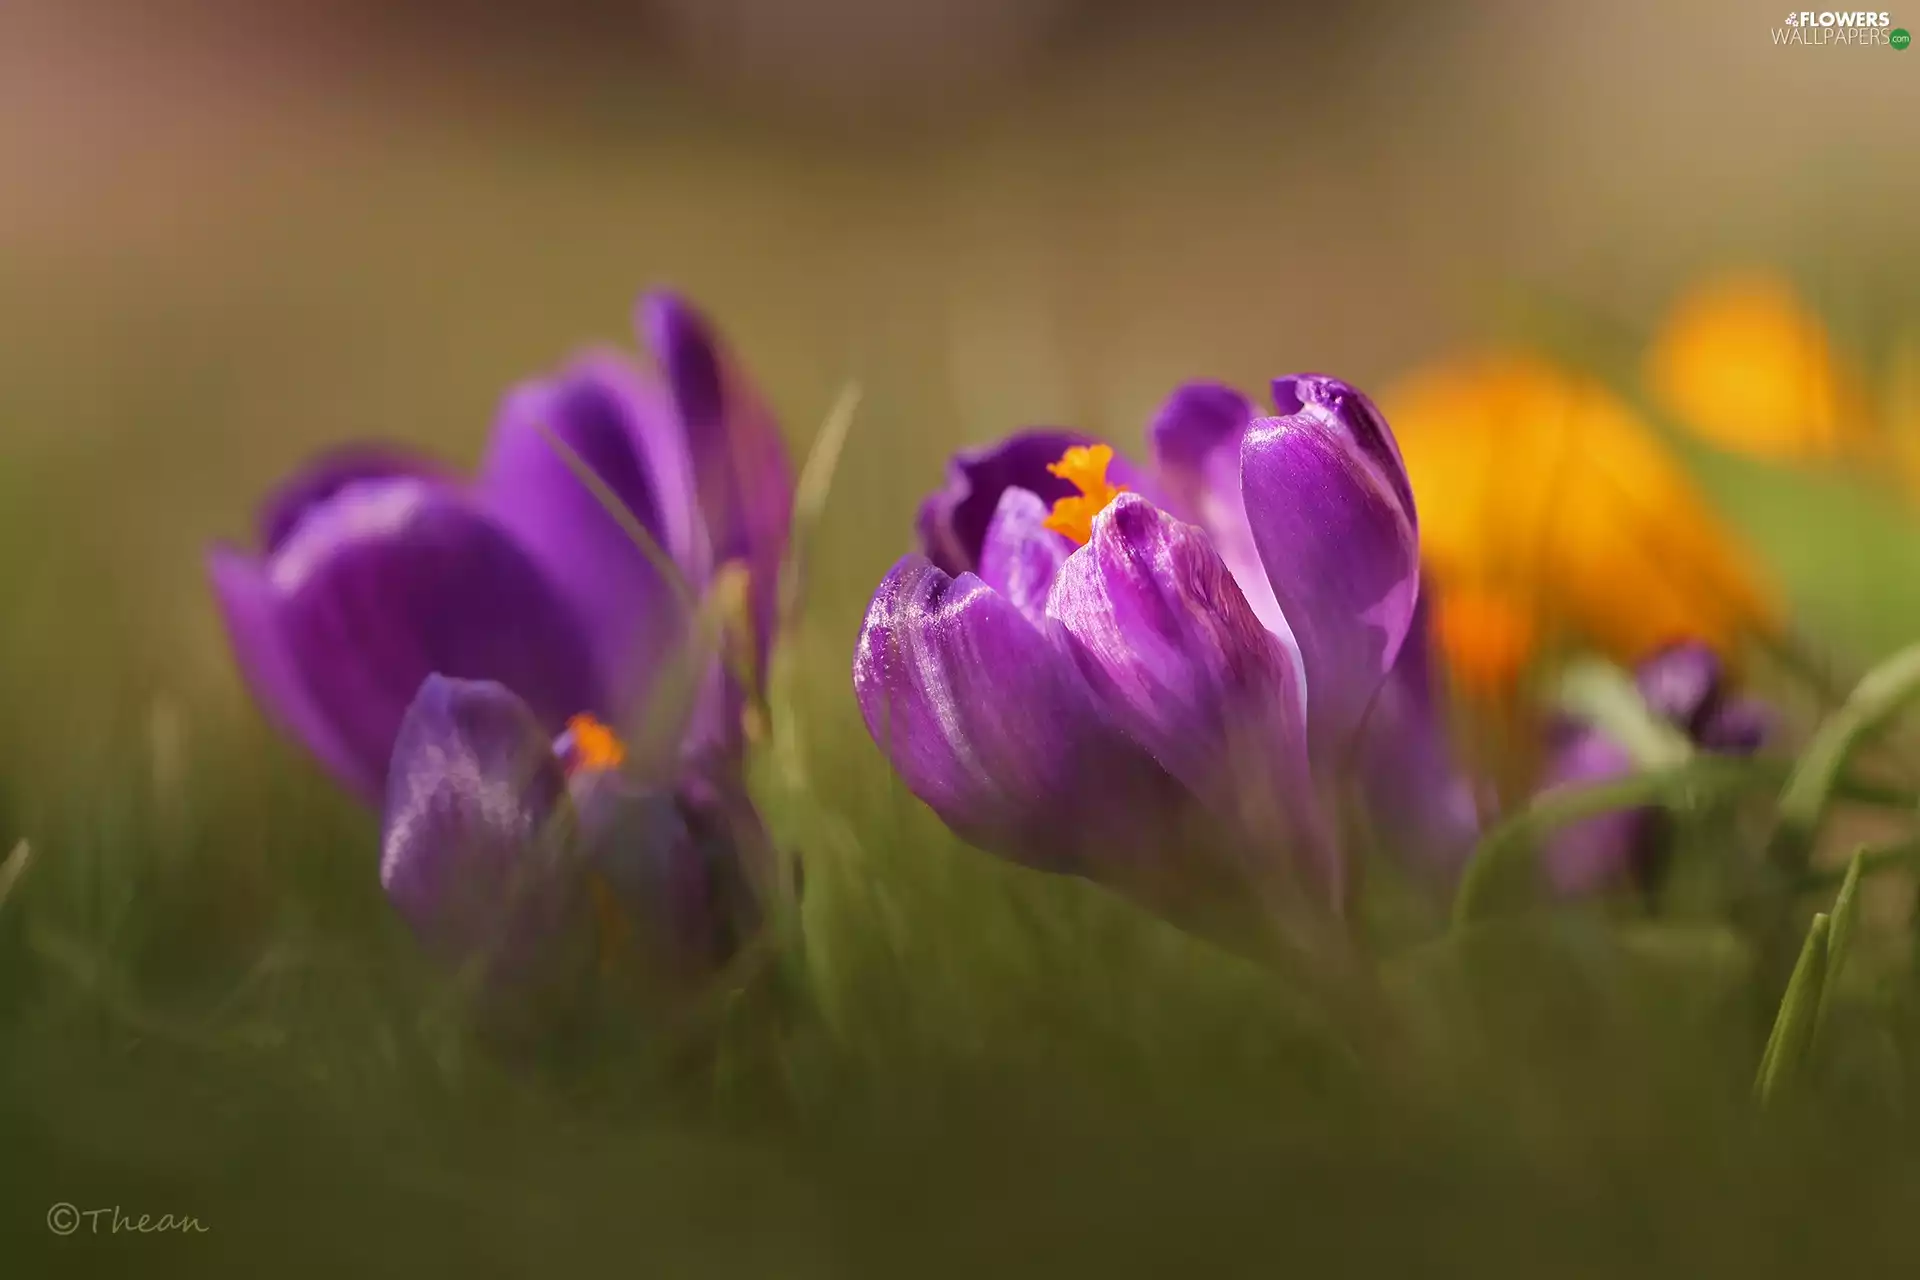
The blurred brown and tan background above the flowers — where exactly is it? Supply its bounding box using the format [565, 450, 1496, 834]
[0, 0, 1920, 740]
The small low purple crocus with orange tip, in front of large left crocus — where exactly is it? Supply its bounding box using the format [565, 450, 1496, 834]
[380, 676, 764, 998]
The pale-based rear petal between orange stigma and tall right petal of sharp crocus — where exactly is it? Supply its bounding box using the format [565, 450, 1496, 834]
[1148, 382, 1304, 656]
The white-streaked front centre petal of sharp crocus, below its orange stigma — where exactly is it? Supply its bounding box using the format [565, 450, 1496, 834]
[1046, 493, 1338, 898]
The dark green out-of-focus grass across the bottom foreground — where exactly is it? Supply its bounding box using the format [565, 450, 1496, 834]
[11, 664, 1920, 1276]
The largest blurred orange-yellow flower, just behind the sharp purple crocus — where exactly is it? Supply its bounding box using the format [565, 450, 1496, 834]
[1382, 351, 1780, 693]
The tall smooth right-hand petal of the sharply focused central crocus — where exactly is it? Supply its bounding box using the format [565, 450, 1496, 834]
[1240, 413, 1419, 762]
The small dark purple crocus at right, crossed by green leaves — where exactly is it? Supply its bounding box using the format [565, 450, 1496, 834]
[1542, 641, 1772, 896]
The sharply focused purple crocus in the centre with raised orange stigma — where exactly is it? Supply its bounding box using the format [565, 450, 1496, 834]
[854, 374, 1473, 932]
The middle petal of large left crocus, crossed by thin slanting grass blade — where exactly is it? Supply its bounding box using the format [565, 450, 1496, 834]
[478, 355, 697, 708]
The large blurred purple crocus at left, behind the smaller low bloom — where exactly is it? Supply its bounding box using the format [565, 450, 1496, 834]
[209, 294, 791, 804]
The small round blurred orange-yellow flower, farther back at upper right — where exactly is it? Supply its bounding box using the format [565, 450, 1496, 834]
[1645, 271, 1866, 459]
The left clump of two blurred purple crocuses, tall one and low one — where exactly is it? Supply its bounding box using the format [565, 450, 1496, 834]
[207, 296, 793, 981]
